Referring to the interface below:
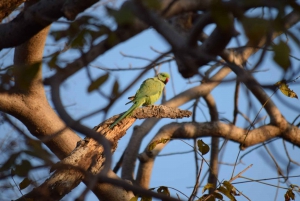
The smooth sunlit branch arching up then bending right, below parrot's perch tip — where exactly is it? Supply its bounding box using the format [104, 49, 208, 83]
[138, 122, 300, 190]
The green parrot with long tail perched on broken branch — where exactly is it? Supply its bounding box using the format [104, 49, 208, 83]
[109, 73, 170, 129]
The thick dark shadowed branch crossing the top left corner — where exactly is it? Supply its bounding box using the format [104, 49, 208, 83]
[0, 0, 106, 50]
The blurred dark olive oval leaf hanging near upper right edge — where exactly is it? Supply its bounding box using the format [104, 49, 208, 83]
[272, 41, 291, 71]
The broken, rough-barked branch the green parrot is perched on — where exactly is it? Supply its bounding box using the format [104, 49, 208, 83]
[17, 106, 191, 200]
